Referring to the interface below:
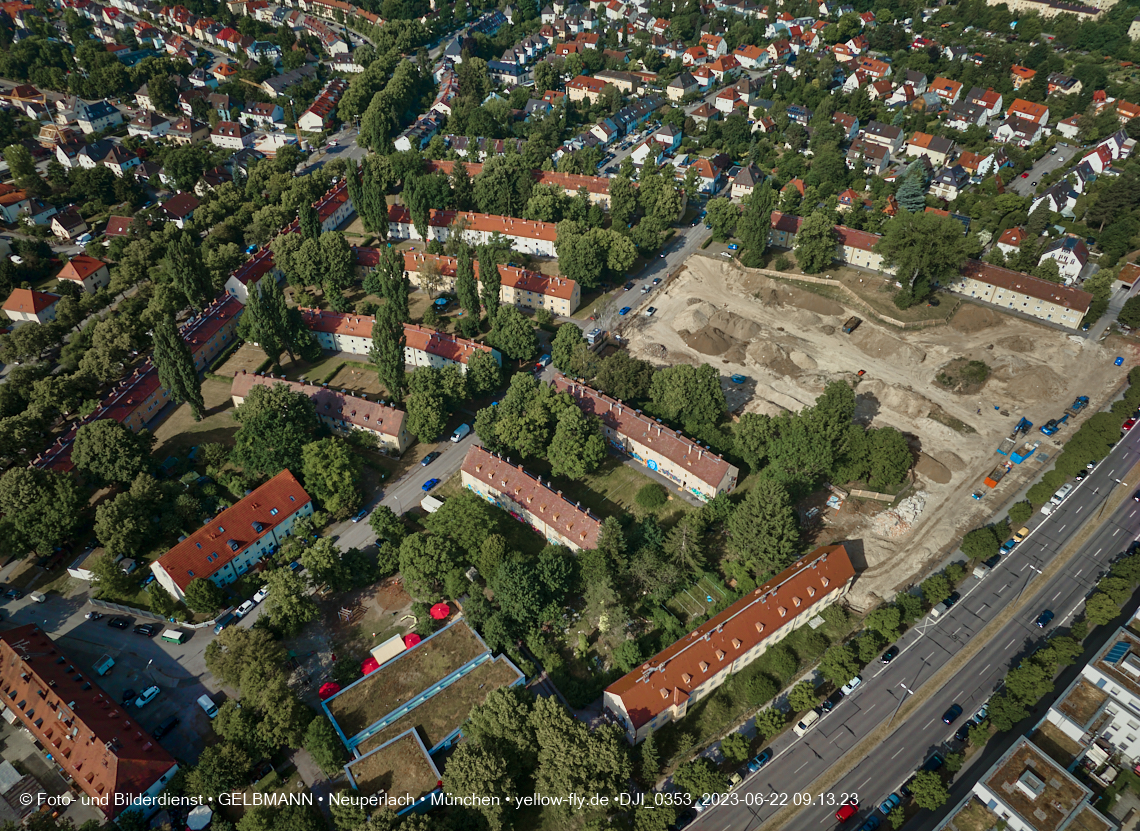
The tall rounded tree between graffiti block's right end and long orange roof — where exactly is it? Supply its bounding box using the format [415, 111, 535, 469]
[727, 479, 799, 577]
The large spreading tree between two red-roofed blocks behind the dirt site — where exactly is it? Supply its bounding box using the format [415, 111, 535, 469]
[874, 211, 979, 308]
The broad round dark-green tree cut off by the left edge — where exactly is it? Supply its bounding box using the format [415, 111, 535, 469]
[0, 462, 87, 554]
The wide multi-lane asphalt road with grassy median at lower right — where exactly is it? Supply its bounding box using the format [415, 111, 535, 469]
[691, 421, 1140, 831]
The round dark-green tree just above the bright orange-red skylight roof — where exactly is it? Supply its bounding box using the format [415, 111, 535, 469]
[233, 384, 317, 476]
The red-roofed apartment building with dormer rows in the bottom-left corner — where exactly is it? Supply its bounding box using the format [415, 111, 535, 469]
[0, 624, 178, 820]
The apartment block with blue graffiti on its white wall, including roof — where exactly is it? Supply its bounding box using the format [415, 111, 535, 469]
[554, 373, 740, 500]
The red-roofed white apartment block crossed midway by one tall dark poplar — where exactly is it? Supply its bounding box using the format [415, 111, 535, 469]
[300, 309, 503, 372]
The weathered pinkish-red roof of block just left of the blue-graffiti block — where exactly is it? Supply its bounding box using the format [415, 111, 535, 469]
[463, 445, 602, 548]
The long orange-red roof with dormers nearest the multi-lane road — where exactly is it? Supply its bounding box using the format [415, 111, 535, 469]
[605, 545, 855, 730]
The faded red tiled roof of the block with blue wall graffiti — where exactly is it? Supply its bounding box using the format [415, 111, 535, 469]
[554, 373, 732, 488]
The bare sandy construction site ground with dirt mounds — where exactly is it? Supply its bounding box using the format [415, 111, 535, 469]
[621, 254, 1137, 606]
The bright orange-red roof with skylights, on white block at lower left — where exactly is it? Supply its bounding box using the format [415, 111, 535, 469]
[157, 471, 311, 590]
